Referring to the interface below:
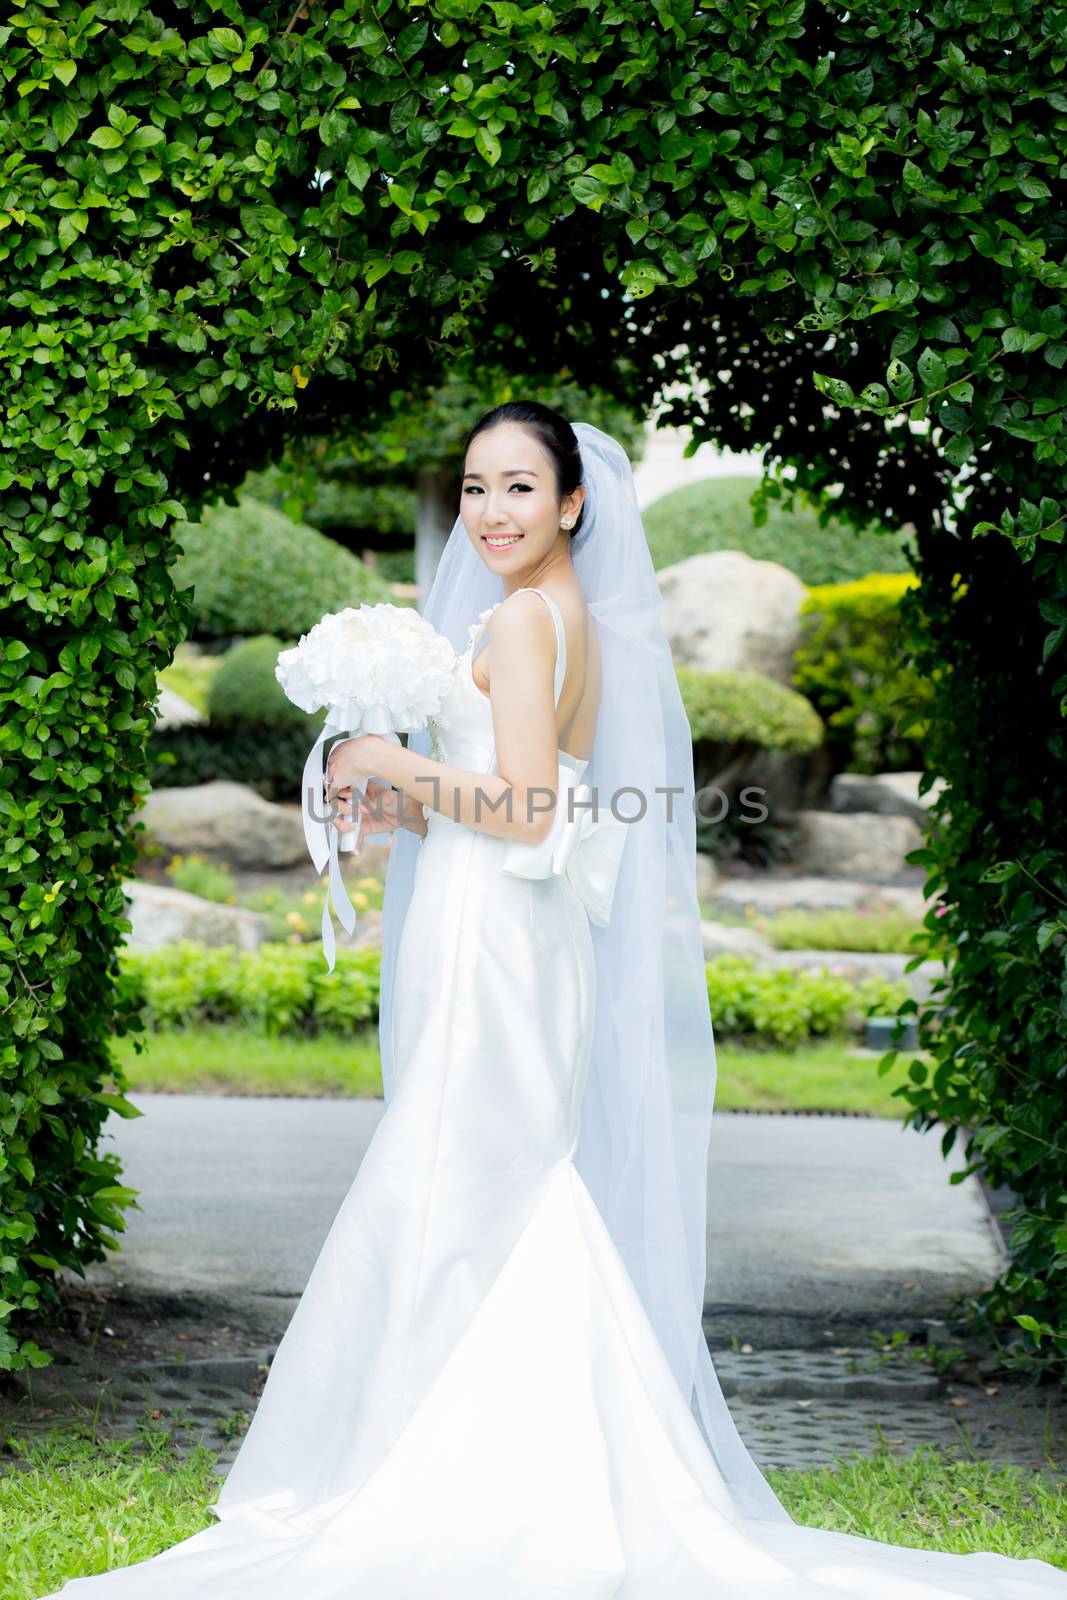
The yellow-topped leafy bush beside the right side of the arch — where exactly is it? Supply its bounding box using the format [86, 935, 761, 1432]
[793, 573, 934, 773]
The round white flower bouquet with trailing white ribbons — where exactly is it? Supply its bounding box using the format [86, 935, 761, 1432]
[275, 602, 456, 971]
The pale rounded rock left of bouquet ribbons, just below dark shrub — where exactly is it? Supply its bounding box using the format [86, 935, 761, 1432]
[139, 779, 310, 870]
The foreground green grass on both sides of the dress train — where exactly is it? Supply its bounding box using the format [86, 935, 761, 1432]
[0, 1430, 1067, 1600]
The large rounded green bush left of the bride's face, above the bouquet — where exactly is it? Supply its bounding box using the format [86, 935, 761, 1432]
[174, 499, 394, 638]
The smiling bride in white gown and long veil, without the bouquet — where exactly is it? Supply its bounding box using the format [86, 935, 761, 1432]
[37, 402, 1067, 1600]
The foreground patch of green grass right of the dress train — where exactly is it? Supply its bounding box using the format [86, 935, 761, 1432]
[768, 1445, 1067, 1568]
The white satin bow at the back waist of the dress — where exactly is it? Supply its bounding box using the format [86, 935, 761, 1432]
[502, 762, 629, 928]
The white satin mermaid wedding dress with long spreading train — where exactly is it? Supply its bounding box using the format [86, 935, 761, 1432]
[45, 590, 1067, 1600]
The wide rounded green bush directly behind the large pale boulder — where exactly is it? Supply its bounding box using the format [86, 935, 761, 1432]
[641, 477, 910, 584]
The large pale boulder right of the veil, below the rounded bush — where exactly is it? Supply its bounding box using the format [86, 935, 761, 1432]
[659, 550, 806, 683]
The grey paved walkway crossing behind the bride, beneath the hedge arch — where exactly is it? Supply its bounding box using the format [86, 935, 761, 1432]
[8, 1094, 1067, 1469]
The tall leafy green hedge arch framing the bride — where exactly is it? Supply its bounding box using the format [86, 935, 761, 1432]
[0, 0, 1067, 1363]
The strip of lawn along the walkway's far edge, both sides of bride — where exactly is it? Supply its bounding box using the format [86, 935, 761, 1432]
[114, 1026, 912, 1117]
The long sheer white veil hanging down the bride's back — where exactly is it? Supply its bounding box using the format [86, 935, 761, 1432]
[379, 422, 792, 1522]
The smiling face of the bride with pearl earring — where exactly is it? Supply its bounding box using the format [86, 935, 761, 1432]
[459, 422, 582, 576]
